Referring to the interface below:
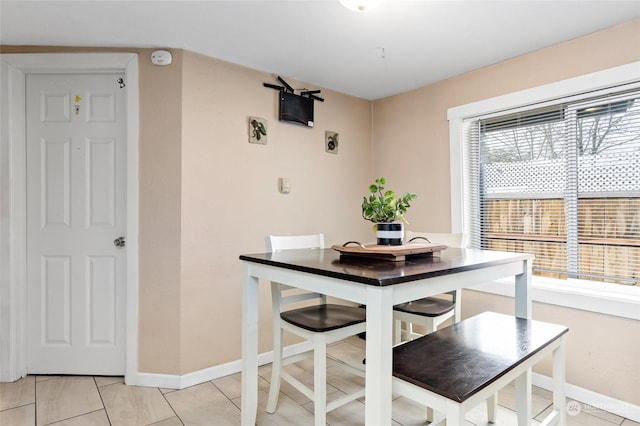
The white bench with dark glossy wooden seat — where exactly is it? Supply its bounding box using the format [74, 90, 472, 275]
[393, 312, 568, 426]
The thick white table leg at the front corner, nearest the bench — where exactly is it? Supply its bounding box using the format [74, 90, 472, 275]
[365, 287, 393, 426]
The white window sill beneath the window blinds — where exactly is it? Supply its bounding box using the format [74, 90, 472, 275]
[474, 277, 640, 320]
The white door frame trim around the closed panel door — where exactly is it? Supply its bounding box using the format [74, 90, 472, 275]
[0, 53, 139, 384]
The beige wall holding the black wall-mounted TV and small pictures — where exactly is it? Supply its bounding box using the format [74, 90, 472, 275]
[180, 52, 371, 373]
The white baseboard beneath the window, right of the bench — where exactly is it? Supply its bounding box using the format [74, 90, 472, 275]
[531, 373, 640, 423]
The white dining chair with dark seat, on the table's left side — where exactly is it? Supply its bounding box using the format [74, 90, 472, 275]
[266, 234, 366, 426]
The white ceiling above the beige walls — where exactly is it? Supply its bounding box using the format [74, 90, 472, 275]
[0, 0, 640, 100]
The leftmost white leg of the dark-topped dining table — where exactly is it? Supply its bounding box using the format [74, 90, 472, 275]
[240, 263, 258, 426]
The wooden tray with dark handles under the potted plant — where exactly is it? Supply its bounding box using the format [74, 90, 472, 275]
[331, 241, 447, 262]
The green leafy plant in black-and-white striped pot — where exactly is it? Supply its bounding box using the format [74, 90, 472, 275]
[362, 177, 417, 246]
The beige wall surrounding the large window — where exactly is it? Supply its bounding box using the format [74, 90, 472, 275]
[373, 20, 640, 405]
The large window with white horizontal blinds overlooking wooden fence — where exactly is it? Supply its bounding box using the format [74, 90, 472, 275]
[463, 89, 640, 285]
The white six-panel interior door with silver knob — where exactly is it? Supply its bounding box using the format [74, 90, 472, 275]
[26, 74, 126, 375]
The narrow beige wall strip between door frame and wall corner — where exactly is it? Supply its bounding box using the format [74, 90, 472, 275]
[138, 50, 183, 374]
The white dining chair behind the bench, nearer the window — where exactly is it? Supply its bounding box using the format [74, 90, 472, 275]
[393, 231, 462, 344]
